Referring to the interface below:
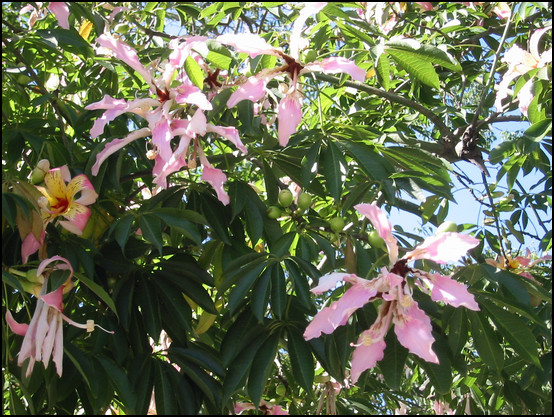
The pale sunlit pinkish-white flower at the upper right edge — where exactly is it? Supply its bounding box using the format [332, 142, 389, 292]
[494, 26, 552, 116]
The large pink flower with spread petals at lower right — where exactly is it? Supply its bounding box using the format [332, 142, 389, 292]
[304, 204, 479, 383]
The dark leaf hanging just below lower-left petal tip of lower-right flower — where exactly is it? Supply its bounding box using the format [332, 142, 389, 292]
[287, 327, 314, 394]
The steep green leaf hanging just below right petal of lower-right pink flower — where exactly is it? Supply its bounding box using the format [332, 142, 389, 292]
[467, 310, 504, 372]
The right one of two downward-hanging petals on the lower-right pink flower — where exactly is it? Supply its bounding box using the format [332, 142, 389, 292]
[392, 301, 439, 363]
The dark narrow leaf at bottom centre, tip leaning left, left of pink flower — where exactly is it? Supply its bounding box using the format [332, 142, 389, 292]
[247, 333, 279, 404]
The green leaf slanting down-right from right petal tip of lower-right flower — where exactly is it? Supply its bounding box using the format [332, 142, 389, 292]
[482, 303, 541, 368]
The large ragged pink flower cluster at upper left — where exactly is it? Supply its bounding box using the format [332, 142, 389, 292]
[85, 34, 247, 204]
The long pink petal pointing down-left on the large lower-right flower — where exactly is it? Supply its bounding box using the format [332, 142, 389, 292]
[304, 285, 377, 340]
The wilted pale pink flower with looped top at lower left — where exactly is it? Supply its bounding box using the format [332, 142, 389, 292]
[5, 256, 113, 377]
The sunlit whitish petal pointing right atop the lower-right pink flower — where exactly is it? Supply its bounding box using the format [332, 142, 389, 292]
[403, 232, 479, 264]
